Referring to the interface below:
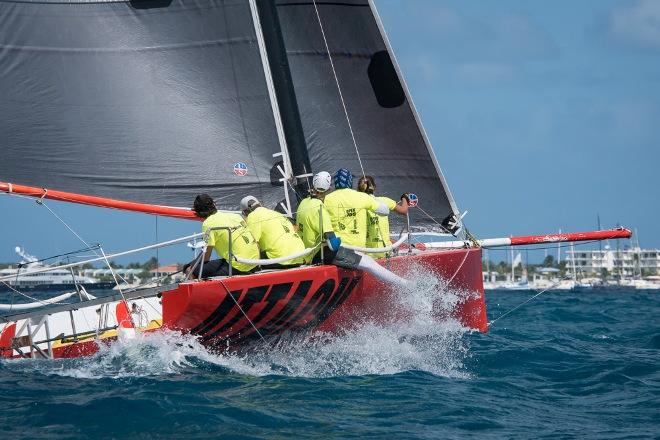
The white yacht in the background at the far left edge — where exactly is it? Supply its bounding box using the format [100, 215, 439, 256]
[0, 246, 115, 292]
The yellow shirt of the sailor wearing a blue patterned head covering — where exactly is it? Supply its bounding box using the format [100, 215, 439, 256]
[324, 188, 379, 247]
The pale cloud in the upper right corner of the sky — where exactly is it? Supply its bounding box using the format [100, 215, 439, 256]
[608, 0, 660, 49]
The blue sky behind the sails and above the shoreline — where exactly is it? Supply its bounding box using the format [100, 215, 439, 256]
[0, 0, 660, 263]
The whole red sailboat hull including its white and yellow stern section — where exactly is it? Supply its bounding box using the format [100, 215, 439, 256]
[0, 249, 488, 358]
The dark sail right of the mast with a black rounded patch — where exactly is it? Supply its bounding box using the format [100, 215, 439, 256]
[277, 0, 456, 232]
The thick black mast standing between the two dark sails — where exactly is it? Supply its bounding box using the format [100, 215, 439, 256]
[251, 0, 312, 198]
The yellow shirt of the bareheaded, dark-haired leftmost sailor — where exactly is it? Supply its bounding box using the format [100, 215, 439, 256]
[202, 212, 259, 272]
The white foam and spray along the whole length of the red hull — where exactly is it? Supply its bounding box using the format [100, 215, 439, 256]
[21, 271, 476, 379]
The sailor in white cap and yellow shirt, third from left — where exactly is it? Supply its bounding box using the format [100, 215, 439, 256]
[296, 171, 341, 264]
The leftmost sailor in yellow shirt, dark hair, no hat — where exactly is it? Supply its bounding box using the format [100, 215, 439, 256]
[184, 194, 259, 278]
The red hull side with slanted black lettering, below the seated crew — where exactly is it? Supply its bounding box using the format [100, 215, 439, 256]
[162, 249, 488, 347]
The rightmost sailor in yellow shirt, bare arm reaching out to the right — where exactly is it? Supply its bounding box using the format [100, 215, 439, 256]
[358, 176, 409, 258]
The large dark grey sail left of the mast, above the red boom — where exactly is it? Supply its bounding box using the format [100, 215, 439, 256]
[0, 0, 282, 209]
